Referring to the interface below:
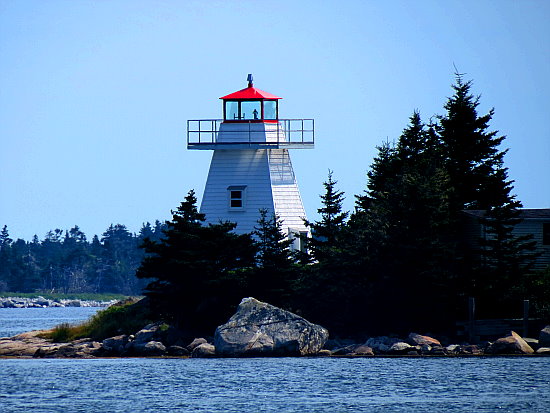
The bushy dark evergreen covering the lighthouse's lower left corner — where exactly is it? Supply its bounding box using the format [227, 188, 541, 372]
[137, 191, 255, 333]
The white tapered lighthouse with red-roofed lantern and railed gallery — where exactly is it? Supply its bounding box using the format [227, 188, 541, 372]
[187, 75, 314, 248]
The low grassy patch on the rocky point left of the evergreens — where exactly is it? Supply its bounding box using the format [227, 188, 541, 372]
[42, 298, 152, 343]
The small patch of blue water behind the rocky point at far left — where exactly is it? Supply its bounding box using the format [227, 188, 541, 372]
[0, 307, 101, 338]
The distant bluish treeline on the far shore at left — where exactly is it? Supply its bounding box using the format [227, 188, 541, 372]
[0, 221, 165, 295]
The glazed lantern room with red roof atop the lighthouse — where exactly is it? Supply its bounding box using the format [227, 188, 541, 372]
[220, 74, 282, 123]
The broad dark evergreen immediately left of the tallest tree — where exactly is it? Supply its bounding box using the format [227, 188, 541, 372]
[349, 112, 449, 329]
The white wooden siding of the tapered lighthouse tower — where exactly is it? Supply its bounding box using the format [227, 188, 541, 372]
[200, 123, 307, 233]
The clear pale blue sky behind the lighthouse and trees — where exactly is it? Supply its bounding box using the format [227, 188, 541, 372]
[0, 0, 550, 240]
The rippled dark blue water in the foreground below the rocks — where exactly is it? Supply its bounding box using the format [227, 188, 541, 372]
[0, 357, 550, 413]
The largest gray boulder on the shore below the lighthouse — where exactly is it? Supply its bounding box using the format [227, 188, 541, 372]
[214, 298, 328, 357]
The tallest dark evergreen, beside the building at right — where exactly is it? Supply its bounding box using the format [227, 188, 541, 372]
[435, 74, 534, 315]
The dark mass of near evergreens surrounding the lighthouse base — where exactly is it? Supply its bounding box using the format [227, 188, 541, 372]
[137, 74, 550, 335]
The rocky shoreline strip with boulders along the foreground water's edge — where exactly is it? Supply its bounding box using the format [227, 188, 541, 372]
[0, 298, 550, 358]
